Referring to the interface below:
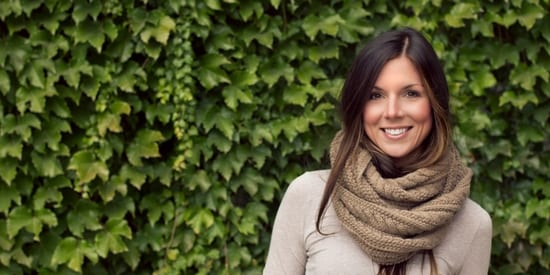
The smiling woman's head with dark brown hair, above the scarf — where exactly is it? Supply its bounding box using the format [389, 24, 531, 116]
[341, 28, 451, 177]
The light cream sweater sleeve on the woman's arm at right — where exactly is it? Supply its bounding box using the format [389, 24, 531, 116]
[459, 202, 492, 275]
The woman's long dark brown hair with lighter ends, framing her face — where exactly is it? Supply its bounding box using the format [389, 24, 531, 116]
[316, 28, 452, 274]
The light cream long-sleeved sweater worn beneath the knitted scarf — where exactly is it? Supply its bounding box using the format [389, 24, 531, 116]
[263, 170, 492, 275]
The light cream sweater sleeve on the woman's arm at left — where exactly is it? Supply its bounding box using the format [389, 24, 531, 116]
[263, 173, 309, 275]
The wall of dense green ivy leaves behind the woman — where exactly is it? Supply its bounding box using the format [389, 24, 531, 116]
[0, 0, 550, 274]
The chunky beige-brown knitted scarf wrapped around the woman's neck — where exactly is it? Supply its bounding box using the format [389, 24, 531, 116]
[330, 134, 472, 265]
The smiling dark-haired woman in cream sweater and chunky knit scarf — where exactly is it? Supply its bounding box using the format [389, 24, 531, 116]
[264, 28, 492, 275]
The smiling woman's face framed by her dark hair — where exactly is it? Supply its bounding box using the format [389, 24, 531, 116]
[363, 56, 432, 159]
